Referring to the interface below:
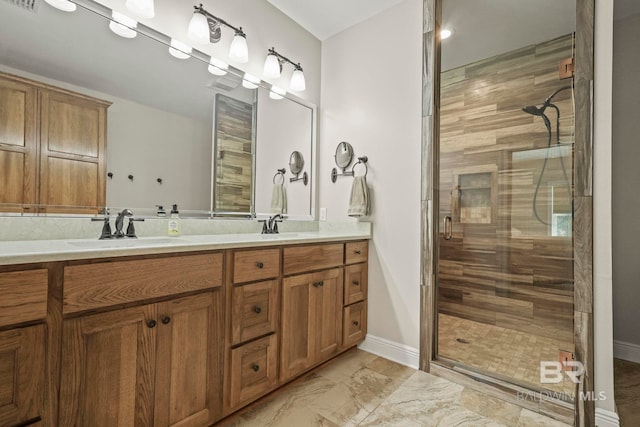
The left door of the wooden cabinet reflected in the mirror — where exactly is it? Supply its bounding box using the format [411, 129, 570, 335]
[0, 78, 37, 211]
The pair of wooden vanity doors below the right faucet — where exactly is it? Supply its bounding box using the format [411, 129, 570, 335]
[280, 268, 343, 381]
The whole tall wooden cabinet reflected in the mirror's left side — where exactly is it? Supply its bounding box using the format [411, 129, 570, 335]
[0, 73, 110, 213]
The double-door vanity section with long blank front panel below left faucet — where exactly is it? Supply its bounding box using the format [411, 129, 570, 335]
[58, 253, 224, 427]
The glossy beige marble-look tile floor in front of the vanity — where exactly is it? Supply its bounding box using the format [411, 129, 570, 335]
[217, 349, 567, 427]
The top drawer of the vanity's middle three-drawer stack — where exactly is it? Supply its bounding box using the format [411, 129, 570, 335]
[233, 249, 280, 283]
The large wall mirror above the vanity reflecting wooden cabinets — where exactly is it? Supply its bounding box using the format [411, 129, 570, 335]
[0, 1, 316, 219]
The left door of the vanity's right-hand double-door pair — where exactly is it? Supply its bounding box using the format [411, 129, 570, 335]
[280, 274, 319, 381]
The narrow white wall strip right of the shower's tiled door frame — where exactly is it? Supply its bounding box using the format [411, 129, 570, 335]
[593, 0, 615, 418]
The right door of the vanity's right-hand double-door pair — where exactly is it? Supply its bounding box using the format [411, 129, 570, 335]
[312, 268, 343, 362]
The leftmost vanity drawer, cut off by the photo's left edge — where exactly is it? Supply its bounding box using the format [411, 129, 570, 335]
[0, 269, 48, 326]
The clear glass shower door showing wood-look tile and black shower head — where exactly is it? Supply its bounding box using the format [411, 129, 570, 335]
[436, 0, 575, 400]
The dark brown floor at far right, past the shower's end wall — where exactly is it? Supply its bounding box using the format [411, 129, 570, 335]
[613, 359, 640, 427]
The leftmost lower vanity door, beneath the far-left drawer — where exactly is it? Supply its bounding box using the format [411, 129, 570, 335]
[0, 325, 45, 426]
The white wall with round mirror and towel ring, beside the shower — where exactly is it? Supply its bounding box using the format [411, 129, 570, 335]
[319, 0, 422, 348]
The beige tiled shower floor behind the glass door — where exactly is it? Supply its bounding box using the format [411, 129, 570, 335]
[438, 314, 575, 396]
